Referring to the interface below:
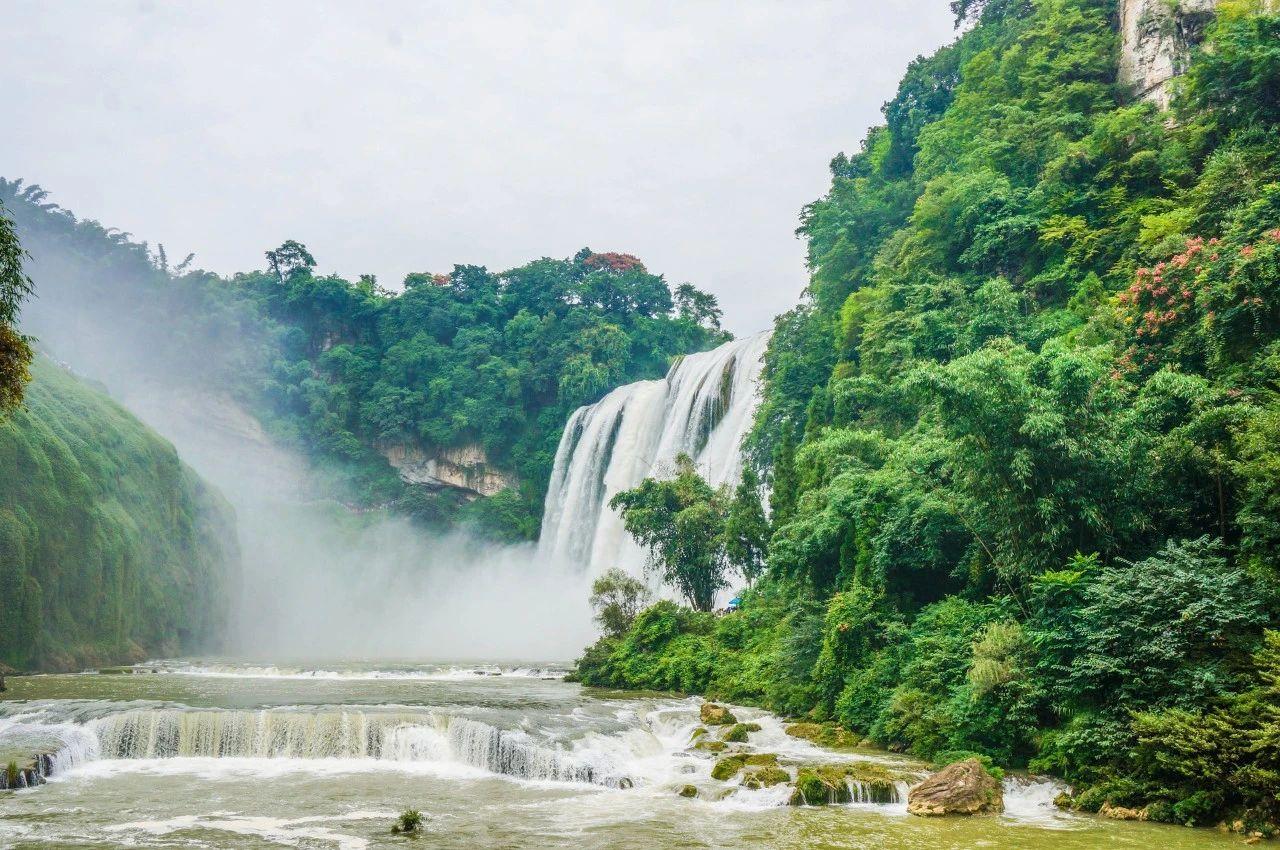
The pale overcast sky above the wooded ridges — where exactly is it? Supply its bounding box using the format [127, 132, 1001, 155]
[0, 0, 952, 334]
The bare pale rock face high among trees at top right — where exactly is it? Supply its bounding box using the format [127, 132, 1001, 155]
[1119, 0, 1280, 109]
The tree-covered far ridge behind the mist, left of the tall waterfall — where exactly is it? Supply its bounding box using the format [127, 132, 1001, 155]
[0, 180, 723, 539]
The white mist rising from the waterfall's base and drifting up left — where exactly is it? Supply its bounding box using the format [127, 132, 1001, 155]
[11, 206, 593, 662]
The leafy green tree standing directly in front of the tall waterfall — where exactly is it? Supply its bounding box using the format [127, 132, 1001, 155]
[609, 454, 728, 611]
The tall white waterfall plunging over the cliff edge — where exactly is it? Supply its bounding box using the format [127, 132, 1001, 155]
[540, 333, 769, 573]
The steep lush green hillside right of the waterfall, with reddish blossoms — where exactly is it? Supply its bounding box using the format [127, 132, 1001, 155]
[577, 0, 1280, 832]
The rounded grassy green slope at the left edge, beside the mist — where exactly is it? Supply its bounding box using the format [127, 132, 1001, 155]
[0, 358, 238, 670]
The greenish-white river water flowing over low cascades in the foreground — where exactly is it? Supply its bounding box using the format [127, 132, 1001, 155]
[0, 662, 1238, 850]
